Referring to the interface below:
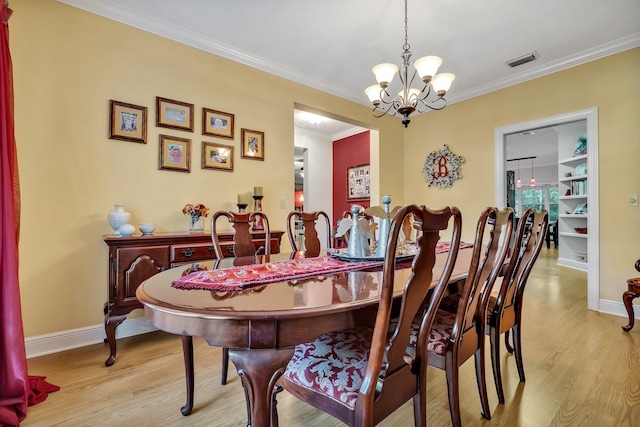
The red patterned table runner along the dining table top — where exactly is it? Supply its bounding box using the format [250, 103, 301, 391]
[171, 242, 473, 291]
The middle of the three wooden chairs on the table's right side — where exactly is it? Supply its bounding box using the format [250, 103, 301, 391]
[400, 207, 514, 426]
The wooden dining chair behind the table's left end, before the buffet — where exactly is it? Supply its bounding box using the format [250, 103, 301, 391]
[211, 211, 271, 385]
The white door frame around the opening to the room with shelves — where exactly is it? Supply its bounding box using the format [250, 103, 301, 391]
[495, 107, 600, 311]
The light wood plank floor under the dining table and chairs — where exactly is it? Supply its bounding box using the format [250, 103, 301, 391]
[22, 249, 640, 427]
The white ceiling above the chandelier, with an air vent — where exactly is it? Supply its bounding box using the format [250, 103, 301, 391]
[58, 0, 640, 138]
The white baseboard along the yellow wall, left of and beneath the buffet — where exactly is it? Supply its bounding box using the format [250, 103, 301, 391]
[24, 317, 157, 359]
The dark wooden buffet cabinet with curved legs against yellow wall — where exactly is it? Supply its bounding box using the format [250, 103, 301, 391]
[104, 230, 284, 366]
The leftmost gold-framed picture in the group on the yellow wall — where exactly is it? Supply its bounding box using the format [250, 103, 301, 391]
[109, 99, 147, 144]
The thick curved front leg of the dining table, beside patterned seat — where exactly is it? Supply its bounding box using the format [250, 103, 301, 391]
[229, 348, 293, 427]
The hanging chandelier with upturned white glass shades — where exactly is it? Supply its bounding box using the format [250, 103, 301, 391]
[364, 0, 456, 127]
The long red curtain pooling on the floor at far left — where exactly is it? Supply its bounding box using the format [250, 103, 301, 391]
[0, 4, 59, 426]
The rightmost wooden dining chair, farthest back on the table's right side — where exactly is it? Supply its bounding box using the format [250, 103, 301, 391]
[485, 208, 549, 403]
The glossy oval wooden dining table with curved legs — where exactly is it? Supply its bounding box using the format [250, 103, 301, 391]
[136, 248, 472, 427]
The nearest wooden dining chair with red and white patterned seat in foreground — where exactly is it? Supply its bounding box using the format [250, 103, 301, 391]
[279, 205, 462, 426]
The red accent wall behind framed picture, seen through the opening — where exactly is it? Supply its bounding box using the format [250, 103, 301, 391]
[332, 131, 370, 225]
